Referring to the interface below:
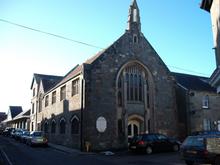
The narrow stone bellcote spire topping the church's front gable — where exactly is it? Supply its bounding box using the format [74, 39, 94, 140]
[127, 0, 141, 32]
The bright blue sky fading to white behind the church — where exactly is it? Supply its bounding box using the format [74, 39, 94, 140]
[0, 0, 216, 112]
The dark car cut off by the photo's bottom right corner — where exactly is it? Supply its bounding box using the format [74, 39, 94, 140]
[180, 135, 220, 165]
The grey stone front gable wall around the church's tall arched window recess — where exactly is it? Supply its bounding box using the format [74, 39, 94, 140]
[84, 32, 177, 150]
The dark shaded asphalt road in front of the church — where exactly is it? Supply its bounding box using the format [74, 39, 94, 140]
[0, 136, 187, 165]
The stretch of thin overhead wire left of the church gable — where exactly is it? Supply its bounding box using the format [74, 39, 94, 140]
[0, 19, 103, 49]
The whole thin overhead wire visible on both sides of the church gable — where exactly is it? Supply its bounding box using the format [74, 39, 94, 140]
[0, 19, 209, 76]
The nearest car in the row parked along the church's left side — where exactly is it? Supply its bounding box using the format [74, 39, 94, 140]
[26, 131, 48, 146]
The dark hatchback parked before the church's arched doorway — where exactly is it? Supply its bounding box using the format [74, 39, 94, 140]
[129, 134, 180, 154]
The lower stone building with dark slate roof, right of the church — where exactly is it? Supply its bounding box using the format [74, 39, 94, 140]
[173, 73, 220, 135]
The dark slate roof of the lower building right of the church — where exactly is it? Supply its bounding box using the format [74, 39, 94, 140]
[172, 72, 216, 92]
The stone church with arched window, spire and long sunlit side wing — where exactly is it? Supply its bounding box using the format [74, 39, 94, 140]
[30, 0, 219, 150]
